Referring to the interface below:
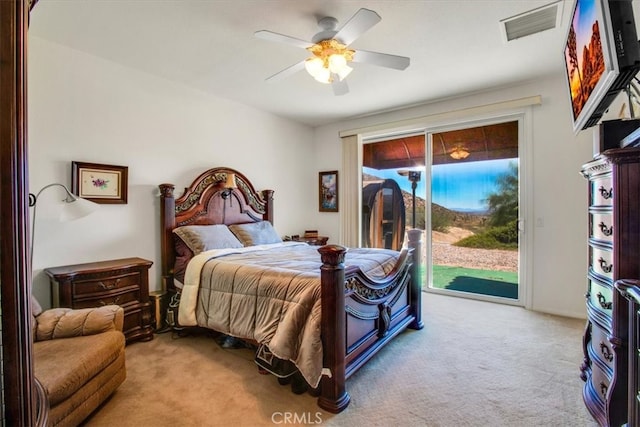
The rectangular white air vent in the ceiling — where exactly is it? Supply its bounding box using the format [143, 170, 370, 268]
[500, 1, 562, 41]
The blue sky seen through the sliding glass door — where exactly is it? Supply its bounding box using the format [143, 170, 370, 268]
[363, 159, 517, 211]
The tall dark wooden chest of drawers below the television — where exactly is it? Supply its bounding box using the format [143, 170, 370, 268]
[580, 148, 640, 426]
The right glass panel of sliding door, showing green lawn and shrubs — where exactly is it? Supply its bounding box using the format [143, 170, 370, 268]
[427, 121, 520, 301]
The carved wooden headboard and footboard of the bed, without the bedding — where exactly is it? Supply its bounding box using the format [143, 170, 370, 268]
[159, 167, 423, 413]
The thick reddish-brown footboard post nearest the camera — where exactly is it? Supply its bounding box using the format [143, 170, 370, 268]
[318, 245, 350, 414]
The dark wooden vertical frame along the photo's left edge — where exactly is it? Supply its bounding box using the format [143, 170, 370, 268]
[0, 0, 37, 426]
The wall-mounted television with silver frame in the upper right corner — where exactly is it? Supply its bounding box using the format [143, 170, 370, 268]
[564, 0, 640, 133]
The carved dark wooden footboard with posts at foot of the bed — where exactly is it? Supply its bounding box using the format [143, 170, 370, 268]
[318, 230, 424, 413]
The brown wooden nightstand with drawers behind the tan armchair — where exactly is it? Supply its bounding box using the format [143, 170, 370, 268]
[44, 258, 153, 344]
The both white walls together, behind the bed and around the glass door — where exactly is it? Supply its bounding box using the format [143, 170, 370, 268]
[29, 37, 632, 317]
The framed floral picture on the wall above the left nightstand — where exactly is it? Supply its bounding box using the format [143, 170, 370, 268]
[71, 161, 128, 204]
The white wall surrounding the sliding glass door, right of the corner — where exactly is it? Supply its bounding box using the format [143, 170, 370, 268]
[315, 75, 604, 317]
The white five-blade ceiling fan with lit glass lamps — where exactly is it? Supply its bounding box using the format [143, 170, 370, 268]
[255, 9, 410, 95]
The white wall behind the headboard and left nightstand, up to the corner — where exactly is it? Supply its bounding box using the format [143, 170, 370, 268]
[28, 37, 317, 306]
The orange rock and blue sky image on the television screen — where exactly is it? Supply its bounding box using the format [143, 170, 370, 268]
[564, 0, 605, 120]
